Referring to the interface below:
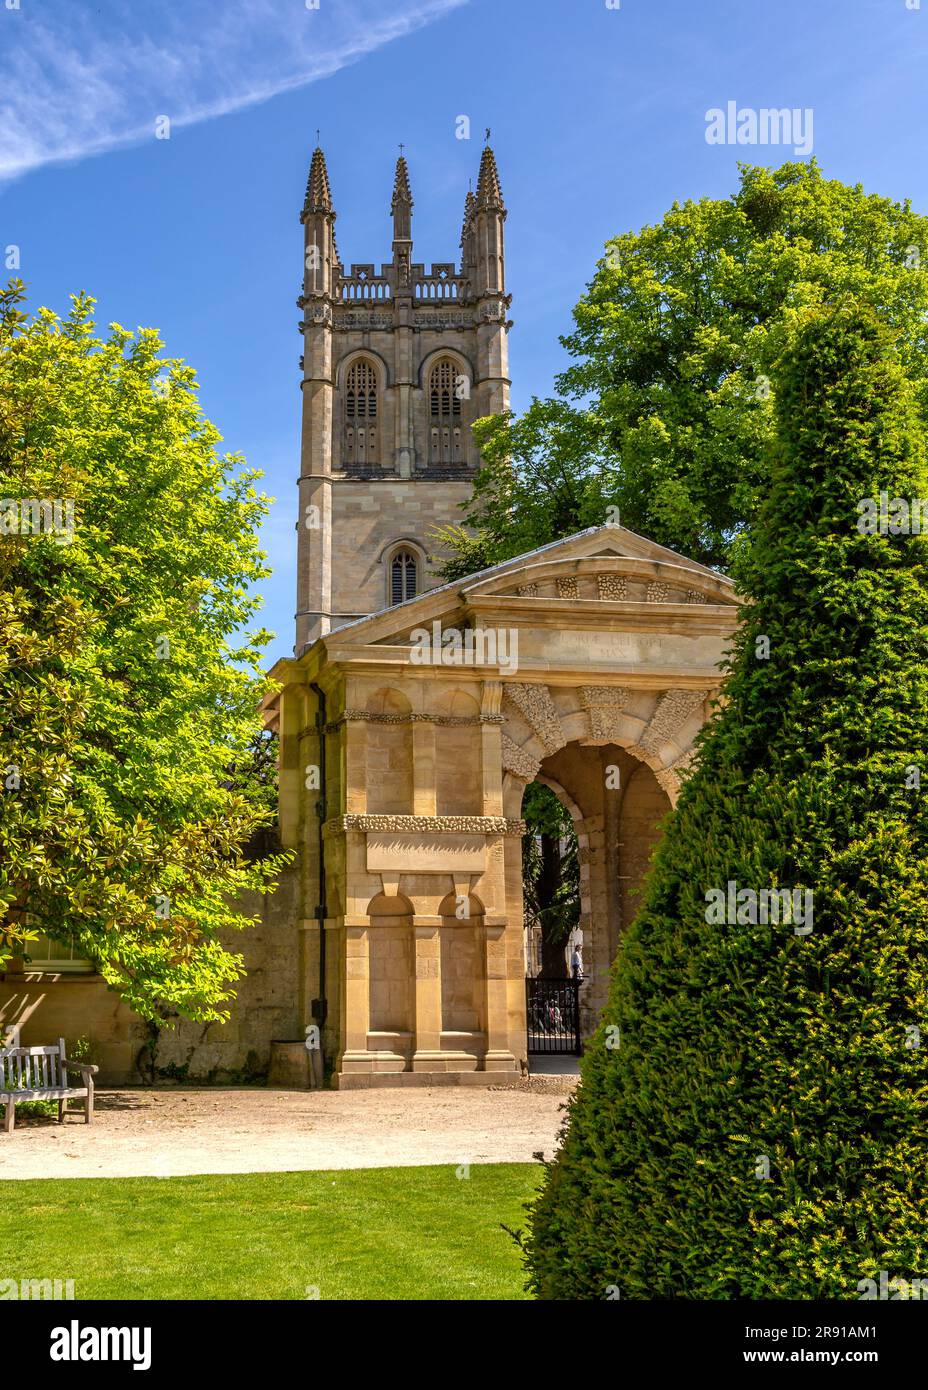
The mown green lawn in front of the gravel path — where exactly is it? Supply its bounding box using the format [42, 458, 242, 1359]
[0, 1163, 542, 1300]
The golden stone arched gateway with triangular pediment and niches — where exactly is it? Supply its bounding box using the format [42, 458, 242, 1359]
[267, 527, 736, 1087]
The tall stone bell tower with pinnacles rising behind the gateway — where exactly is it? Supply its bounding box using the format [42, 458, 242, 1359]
[296, 145, 511, 656]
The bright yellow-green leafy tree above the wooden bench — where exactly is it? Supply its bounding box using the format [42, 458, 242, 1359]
[0, 282, 282, 1020]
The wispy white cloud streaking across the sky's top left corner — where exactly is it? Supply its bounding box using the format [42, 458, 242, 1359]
[0, 0, 467, 181]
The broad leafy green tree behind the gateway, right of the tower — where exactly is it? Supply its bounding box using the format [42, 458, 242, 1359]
[439, 163, 928, 580]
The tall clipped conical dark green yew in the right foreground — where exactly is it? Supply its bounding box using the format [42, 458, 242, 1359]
[527, 302, 928, 1298]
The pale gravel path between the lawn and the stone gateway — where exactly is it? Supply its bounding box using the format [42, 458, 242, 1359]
[0, 1077, 575, 1180]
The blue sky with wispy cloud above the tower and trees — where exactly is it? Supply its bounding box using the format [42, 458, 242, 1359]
[0, 0, 928, 659]
